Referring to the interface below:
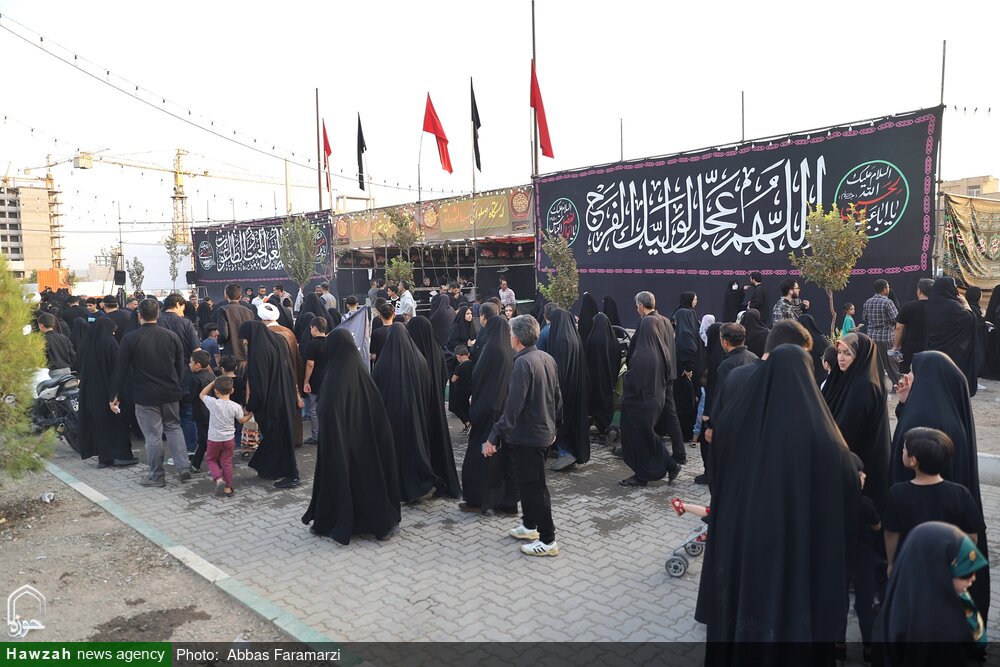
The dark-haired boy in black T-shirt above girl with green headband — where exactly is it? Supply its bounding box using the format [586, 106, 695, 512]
[884, 428, 984, 571]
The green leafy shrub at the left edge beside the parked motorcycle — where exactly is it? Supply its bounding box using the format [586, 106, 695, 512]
[0, 255, 55, 477]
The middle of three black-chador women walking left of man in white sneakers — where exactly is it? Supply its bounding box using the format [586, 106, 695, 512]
[372, 322, 437, 503]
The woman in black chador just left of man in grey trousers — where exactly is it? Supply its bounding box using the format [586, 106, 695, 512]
[73, 317, 138, 468]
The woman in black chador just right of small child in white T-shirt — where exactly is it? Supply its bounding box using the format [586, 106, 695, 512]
[239, 320, 302, 488]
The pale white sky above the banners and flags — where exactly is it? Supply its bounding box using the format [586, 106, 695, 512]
[0, 0, 1000, 268]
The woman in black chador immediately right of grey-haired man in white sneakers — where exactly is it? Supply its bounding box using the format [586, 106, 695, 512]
[545, 310, 584, 463]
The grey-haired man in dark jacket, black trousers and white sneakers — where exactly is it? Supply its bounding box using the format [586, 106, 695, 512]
[483, 315, 562, 556]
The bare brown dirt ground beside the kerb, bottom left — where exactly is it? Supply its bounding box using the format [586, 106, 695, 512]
[0, 472, 290, 642]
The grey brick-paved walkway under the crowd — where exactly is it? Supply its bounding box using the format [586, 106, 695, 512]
[53, 410, 1000, 642]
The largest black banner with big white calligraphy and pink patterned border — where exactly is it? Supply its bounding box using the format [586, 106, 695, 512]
[535, 107, 941, 330]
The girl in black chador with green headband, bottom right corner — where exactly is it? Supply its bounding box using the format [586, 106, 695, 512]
[876, 524, 988, 667]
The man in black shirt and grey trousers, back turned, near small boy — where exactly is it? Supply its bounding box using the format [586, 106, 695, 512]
[109, 299, 191, 486]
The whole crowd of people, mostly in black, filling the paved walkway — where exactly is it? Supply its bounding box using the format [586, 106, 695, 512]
[31, 273, 1000, 664]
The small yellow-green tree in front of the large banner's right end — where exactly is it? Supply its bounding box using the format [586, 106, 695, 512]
[788, 204, 868, 340]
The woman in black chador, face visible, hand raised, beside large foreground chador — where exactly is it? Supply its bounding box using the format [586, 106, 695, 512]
[823, 333, 890, 512]
